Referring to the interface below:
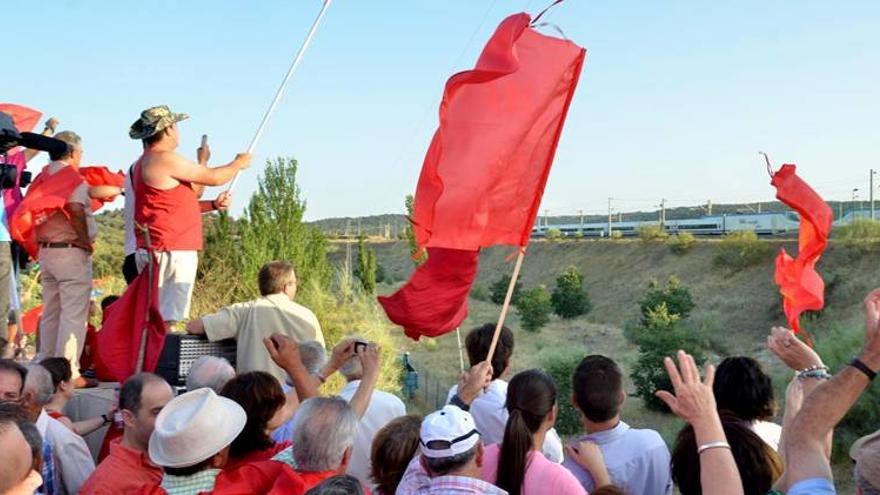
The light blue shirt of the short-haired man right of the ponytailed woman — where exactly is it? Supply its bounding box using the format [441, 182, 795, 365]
[562, 421, 672, 495]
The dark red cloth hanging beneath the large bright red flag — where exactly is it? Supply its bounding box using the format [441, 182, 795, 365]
[379, 248, 479, 340]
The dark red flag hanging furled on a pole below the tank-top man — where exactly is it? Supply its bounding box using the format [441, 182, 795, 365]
[95, 261, 166, 383]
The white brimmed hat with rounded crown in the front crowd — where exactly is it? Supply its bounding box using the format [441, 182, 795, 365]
[149, 388, 247, 468]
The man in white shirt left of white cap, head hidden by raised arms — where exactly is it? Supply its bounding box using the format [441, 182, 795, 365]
[339, 337, 406, 486]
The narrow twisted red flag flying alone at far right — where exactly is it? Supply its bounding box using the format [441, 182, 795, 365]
[771, 164, 834, 340]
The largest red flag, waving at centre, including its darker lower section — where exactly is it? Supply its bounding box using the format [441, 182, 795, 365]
[379, 14, 586, 339]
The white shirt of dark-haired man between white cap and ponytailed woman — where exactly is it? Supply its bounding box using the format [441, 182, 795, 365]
[446, 378, 562, 464]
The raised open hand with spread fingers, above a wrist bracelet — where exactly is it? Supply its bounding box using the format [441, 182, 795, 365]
[656, 351, 718, 425]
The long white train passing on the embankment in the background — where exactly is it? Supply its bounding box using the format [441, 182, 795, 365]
[532, 212, 800, 237]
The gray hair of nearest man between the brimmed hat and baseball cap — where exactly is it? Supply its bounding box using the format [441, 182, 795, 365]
[293, 396, 358, 472]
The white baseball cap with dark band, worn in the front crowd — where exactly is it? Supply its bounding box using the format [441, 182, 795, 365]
[419, 405, 480, 459]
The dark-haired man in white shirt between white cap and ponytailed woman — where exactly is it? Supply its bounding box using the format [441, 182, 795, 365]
[446, 324, 562, 463]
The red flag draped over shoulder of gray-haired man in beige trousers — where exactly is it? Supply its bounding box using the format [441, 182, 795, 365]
[9, 166, 83, 259]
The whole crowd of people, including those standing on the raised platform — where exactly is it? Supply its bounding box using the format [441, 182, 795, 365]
[0, 106, 880, 495]
